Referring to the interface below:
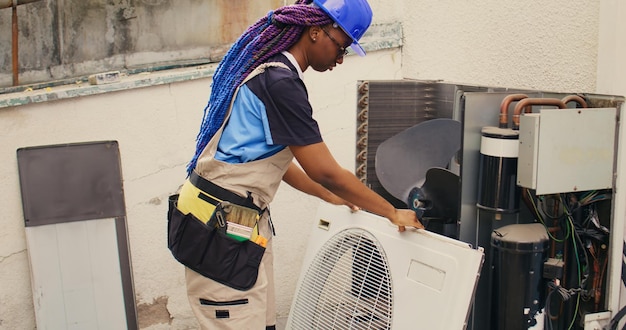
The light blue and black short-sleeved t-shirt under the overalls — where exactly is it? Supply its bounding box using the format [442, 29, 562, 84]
[215, 54, 322, 164]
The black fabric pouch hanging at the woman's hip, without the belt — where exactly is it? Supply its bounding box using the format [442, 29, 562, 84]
[167, 195, 265, 291]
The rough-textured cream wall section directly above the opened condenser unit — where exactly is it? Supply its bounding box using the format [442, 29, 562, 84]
[402, 0, 600, 92]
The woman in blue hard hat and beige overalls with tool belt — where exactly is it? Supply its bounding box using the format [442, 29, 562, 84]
[168, 0, 423, 329]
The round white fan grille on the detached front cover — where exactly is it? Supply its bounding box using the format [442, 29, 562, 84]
[291, 228, 393, 330]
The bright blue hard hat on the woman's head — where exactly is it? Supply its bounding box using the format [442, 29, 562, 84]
[313, 0, 372, 56]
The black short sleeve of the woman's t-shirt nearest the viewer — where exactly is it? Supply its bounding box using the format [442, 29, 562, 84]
[266, 75, 322, 146]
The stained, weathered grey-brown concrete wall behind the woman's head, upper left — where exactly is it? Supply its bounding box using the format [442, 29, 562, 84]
[0, 0, 284, 87]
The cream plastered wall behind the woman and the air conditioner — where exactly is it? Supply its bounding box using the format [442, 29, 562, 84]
[0, 0, 626, 329]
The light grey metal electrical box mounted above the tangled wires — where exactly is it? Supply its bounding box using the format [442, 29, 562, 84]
[517, 108, 617, 195]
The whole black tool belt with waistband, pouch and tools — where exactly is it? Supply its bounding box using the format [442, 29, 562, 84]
[167, 173, 266, 290]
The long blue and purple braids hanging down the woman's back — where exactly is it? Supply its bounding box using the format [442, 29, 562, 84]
[187, 0, 333, 174]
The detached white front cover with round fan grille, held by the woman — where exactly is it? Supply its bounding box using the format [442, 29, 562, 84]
[287, 204, 484, 330]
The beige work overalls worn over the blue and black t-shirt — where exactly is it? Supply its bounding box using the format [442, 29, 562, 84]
[178, 63, 293, 330]
